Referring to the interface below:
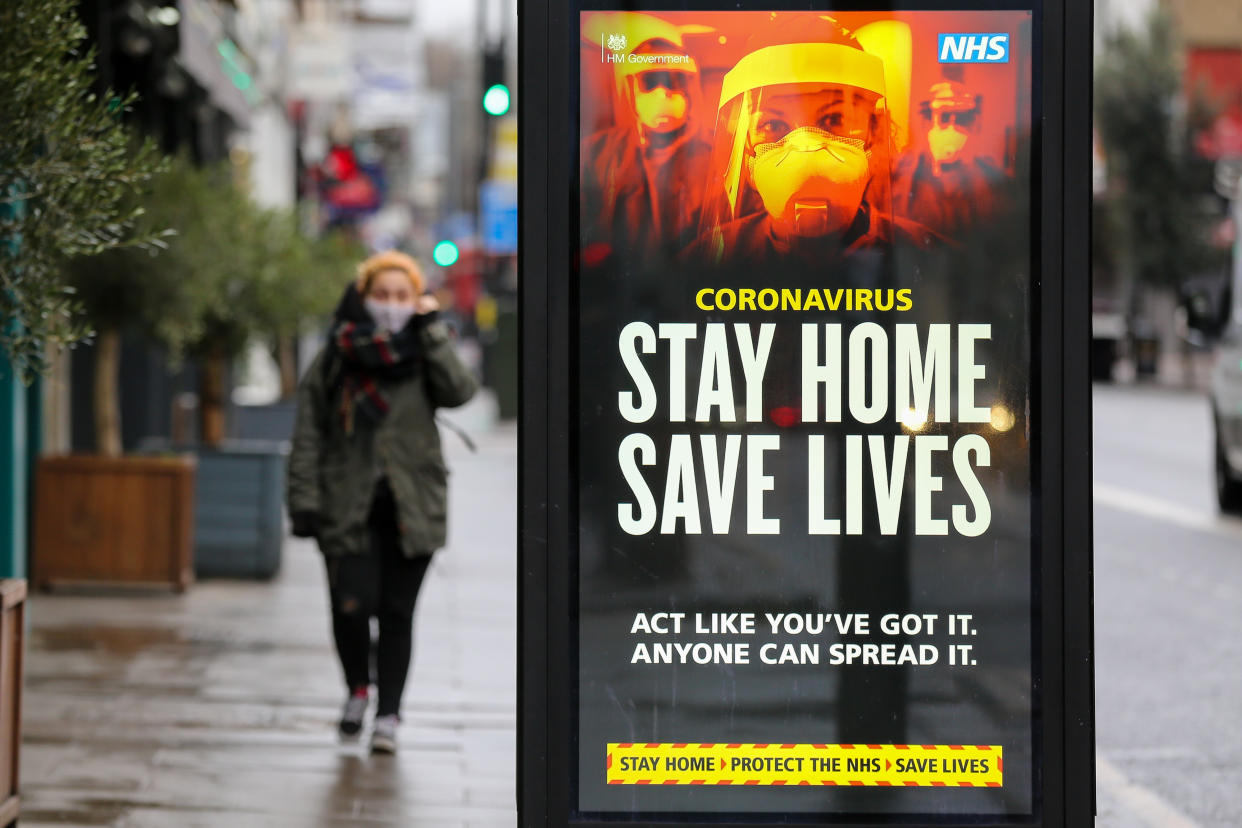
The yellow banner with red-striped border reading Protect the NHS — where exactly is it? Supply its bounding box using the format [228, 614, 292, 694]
[607, 742, 1005, 788]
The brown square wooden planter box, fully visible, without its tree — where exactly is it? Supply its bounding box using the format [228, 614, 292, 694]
[31, 456, 194, 592]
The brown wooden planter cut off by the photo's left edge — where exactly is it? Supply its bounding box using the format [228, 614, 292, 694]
[0, 578, 26, 826]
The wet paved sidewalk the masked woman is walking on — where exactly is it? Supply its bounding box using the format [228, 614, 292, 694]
[21, 427, 517, 828]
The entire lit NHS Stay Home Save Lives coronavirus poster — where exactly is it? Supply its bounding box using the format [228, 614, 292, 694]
[576, 4, 1041, 822]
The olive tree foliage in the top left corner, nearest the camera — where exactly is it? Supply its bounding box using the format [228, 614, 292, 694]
[0, 0, 160, 379]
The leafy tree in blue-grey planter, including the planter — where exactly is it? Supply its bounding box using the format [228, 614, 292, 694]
[142, 176, 356, 577]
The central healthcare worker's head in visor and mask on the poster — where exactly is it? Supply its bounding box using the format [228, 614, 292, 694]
[693, 15, 929, 263]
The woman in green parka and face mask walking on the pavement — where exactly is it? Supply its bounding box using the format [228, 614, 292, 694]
[287, 252, 477, 754]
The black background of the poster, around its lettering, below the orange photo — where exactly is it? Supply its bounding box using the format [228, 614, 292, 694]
[573, 12, 1038, 817]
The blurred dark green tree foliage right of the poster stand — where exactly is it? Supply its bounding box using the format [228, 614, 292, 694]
[1094, 9, 1221, 287]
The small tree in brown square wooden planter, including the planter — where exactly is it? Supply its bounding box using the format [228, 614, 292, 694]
[34, 159, 217, 591]
